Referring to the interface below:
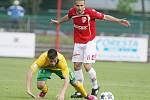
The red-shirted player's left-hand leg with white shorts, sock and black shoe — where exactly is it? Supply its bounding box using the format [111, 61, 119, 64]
[71, 43, 84, 98]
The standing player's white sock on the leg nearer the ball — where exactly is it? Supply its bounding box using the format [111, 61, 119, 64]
[88, 68, 98, 89]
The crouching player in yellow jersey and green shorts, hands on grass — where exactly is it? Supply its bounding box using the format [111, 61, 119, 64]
[26, 49, 94, 100]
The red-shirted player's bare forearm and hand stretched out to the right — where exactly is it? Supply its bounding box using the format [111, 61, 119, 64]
[104, 15, 130, 27]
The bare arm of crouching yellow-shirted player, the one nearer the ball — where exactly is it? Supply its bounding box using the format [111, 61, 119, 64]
[57, 77, 69, 100]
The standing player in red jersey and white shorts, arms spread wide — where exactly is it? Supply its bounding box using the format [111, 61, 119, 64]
[51, 0, 130, 98]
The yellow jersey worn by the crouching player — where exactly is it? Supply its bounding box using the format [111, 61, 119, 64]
[31, 52, 69, 77]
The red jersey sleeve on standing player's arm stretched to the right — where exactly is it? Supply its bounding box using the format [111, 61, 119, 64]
[90, 9, 104, 20]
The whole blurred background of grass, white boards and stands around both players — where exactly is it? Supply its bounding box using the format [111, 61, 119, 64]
[0, 0, 150, 100]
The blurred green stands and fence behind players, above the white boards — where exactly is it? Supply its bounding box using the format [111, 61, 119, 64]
[0, 0, 150, 61]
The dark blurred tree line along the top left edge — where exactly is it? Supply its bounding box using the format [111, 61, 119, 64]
[0, 0, 73, 14]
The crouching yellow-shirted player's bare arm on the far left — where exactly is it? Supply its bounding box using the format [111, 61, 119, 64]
[26, 69, 35, 98]
